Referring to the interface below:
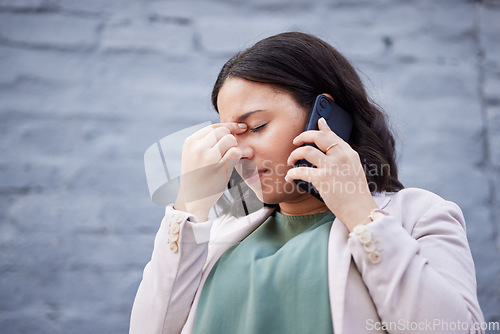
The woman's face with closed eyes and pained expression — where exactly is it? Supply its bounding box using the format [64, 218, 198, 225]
[217, 78, 307, 204]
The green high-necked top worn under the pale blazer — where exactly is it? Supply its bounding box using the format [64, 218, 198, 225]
[193, 211, 335, 334]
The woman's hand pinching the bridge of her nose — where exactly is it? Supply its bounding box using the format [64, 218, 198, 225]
[175, 123, 247, 222]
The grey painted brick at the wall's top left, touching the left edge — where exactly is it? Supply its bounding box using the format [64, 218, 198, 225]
[0, 13, 98, 50]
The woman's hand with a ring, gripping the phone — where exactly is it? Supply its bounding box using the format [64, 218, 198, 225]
[285, 118, 378, 231]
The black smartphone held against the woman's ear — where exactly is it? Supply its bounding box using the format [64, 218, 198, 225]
[294, 94, 352, 201]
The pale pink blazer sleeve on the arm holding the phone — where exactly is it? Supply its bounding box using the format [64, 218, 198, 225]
[348, 190, 484, 333]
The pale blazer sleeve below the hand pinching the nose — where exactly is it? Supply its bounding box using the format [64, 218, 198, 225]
[130, 206, 212, 334]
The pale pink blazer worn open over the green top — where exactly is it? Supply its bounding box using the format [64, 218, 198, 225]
[130, 189, 484, 334]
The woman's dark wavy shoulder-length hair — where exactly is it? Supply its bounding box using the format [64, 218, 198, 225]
[212, 32, 403, 192]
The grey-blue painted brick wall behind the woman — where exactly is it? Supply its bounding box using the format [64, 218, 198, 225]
[0, 0, 500, 334]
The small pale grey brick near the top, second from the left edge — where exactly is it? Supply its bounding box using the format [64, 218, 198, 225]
[101, 22, 193, 56]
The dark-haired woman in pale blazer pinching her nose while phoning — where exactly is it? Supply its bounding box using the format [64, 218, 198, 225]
[130, 33, 483, 334]
